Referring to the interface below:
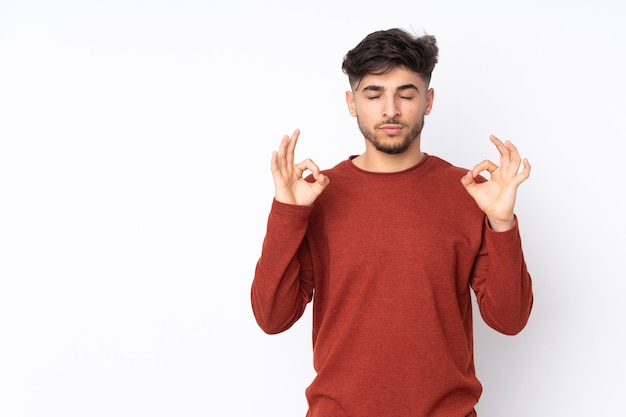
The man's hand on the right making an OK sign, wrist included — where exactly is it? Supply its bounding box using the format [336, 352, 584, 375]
[461, 135, 530, 231]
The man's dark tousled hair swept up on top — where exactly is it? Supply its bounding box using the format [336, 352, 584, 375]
[341, 28, 439, 88]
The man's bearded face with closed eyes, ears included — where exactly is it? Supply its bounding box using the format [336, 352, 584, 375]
[346, 67, 434, 154]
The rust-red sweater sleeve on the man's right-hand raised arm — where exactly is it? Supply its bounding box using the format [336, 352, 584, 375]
[472, 216, 533, 335]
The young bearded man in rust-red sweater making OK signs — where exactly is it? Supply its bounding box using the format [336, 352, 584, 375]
[251, 29, 533, 417]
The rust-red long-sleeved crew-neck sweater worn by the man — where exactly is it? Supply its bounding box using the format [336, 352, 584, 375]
[251, 155, 533, 417]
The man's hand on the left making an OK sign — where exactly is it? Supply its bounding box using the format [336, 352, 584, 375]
[272, 129, 329, 205]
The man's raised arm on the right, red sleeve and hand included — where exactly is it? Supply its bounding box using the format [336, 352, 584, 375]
[461, 136, 533, 334]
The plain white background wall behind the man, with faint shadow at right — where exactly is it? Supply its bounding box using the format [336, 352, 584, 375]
[0, 0, 626, 417]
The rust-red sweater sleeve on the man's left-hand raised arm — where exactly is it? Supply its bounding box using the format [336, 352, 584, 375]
[251, 200, 313, 334]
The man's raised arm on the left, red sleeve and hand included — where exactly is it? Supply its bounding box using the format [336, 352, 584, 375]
[251, 129, 329, 333]
